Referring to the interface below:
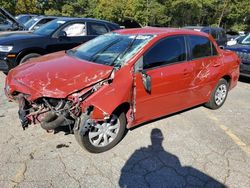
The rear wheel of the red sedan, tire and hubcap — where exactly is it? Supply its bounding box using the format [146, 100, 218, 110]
[205, 78, 229, 110]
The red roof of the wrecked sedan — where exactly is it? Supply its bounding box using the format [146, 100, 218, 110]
[115, 27, 208, 37]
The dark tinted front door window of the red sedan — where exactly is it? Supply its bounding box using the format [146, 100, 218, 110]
[143, 36, 187, 69]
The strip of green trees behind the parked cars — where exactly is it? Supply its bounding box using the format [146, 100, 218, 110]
[0, 0, 250, 31]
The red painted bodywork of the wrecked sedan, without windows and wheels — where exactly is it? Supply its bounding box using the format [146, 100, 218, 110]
[6, 27, 239, 127]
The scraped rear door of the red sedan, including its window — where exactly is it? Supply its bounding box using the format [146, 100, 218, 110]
[187, 35, 223, 105]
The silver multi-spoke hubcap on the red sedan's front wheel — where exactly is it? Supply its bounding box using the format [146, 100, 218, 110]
[89, 115, 120, 147]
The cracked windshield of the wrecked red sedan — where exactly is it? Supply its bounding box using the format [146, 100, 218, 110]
[67, 33, 153, 67]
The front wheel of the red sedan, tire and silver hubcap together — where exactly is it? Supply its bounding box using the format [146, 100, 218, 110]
[74, 113, 126, 153]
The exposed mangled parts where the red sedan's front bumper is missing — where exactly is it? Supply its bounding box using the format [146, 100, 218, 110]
[17, 93, 77, 130]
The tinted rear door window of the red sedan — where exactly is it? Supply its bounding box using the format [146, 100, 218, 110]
[189, 36, 212, 59]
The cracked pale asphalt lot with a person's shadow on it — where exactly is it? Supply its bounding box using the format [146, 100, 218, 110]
[0, 73, 250, 188]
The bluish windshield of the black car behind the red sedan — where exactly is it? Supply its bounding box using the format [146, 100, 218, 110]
[33, 19, 66, 35]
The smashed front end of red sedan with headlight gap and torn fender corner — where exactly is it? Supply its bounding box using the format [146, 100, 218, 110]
[12, 76, 111, 131]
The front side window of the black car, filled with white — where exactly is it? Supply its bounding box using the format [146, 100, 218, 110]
[63, 23, 86, 37]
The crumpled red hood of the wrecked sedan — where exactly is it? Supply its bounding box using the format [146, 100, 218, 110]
[6, 52, 113, 100]
